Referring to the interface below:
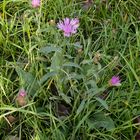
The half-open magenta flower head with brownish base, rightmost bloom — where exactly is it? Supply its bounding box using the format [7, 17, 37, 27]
[109, 76, 121, 86]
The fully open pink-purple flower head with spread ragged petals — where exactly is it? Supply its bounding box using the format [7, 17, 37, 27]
[57, 18, 79, 37]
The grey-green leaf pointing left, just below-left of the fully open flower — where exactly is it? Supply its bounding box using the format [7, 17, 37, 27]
[39, 46, 61, 55]
